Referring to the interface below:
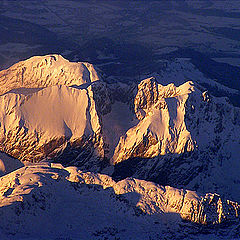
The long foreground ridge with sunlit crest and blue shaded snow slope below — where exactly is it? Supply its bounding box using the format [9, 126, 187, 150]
[0, 164, 240, 240]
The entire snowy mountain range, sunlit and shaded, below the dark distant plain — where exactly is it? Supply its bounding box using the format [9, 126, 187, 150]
[0, 54, 240, 240]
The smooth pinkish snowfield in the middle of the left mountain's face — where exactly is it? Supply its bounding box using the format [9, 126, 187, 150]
[19, 86, 92, 140]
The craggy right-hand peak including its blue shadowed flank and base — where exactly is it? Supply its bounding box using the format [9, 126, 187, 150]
[113, 79, 240, 200]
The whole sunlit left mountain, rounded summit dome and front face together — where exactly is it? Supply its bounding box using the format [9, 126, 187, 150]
[0, 55, 104, 167]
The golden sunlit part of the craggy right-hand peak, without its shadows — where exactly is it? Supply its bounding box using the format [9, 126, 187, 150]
[113, 78, 194, 164]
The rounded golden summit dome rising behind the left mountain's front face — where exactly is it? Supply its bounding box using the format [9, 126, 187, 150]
[0, 54, 100, 95]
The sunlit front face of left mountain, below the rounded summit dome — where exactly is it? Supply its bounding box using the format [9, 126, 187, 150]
[0, 83, 104, 165]
